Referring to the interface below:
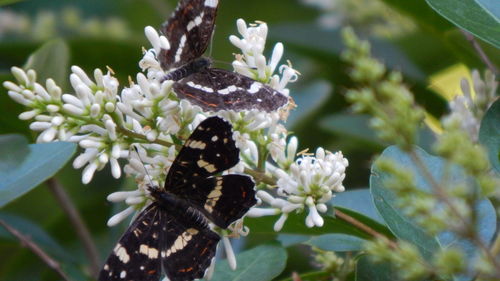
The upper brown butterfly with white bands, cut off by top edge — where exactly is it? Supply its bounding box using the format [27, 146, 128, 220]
[158, 0, 288, 112]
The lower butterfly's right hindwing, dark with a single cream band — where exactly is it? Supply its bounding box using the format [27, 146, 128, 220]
[188, 175, 257, 228]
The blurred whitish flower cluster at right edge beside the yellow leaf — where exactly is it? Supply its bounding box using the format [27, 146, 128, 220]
[443, 70, 498, 142]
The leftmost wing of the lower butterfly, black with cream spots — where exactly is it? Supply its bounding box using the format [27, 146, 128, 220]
[98, 204, 164, 281]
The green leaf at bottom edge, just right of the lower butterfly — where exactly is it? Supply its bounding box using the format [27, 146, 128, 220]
[211, 245, 287, 281]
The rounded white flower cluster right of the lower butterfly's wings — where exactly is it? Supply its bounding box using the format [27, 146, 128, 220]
[248, 137, 349, 231]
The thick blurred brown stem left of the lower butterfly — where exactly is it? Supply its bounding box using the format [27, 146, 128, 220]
[47, 178, 100, 277]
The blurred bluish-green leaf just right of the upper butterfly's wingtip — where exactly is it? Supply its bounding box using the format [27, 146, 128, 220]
[286, 81, 332, 128]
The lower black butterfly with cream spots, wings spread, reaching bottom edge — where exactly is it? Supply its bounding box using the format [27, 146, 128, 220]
[98, 117, 257, 281]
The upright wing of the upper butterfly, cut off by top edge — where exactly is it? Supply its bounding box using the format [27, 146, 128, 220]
[159, 0, 219, 70]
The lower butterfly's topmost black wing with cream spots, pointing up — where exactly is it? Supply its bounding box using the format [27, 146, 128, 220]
[165, 117, 239, 192]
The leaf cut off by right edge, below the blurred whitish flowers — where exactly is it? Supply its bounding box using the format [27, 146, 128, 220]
[479, 100, 500, 173]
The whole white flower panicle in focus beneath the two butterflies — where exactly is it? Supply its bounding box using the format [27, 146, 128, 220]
[4, 19, 348, 238]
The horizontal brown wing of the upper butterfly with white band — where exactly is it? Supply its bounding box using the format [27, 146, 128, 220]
[173, 68, 288, 112]
